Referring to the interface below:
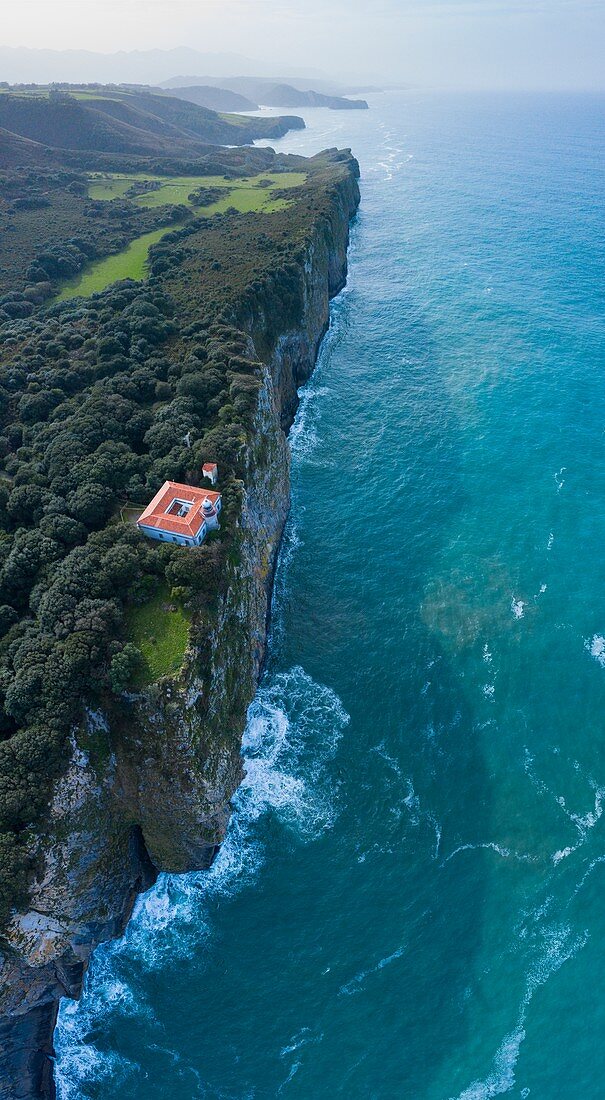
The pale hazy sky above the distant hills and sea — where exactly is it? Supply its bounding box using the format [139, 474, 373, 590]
[0, 0, 605, 88]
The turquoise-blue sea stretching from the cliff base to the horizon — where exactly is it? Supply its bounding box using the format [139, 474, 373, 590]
[57, 94, 605, 1100]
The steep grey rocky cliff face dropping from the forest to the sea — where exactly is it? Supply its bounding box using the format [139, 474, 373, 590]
[0, 161, 359, 1100]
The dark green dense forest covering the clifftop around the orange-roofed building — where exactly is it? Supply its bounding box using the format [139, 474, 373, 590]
[0, 113, 358, 921]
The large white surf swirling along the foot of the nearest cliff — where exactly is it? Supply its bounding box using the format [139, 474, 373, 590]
[55, 668, 349, 1100]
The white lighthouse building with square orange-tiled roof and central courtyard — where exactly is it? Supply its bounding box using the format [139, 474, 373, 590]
[136, 482, 221, 547]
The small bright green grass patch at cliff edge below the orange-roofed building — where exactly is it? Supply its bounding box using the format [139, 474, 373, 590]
[127, 586, 190, 689]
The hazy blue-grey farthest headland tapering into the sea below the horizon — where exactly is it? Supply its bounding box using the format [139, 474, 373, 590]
[163, 76, 367, 111]
